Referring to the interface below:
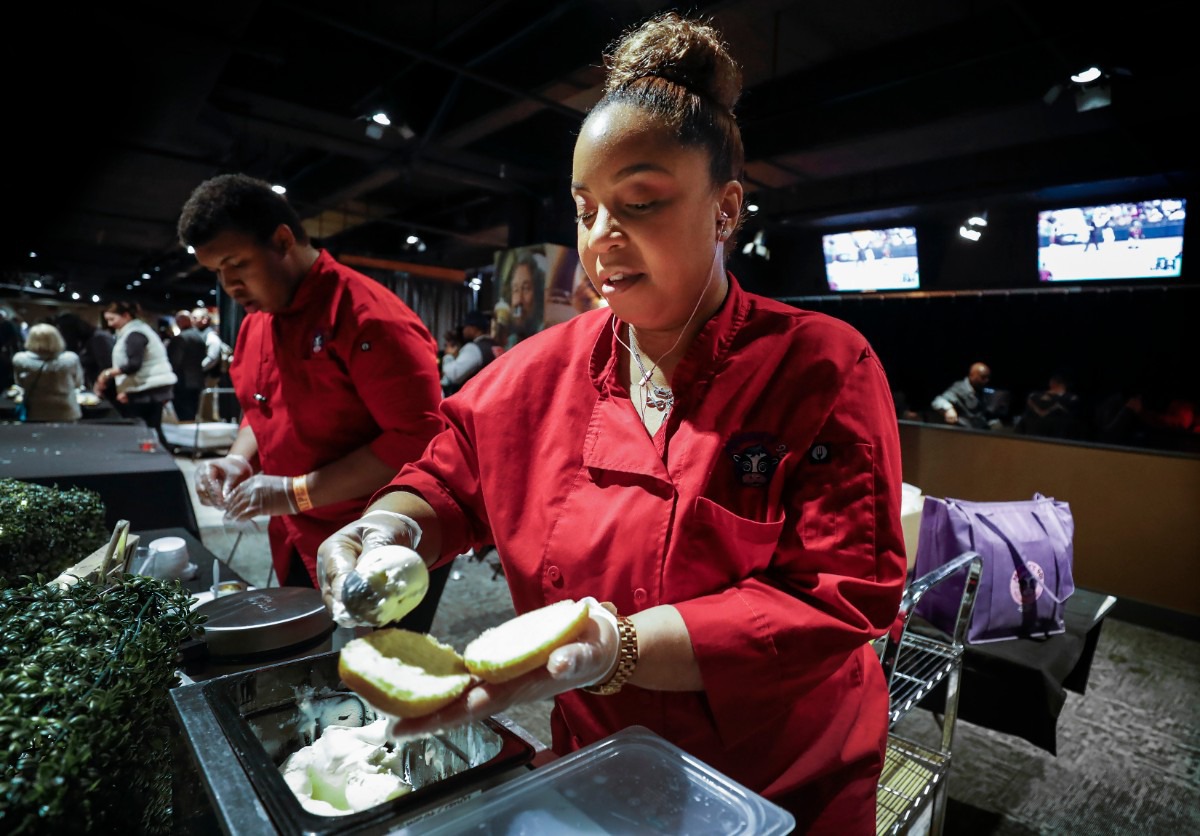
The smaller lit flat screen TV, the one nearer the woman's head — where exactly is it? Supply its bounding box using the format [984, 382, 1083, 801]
[821, 227, 920, 293]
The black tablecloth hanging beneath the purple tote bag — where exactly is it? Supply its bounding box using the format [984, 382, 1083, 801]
[912, 589, 1116, 754]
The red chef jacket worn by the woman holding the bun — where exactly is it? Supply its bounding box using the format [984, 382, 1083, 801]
[380, 276, 906, 810]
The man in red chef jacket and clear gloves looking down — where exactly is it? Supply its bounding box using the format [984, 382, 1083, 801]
[178, 174, 444, 599]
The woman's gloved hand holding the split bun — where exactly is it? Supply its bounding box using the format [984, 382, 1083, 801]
[391, 597, 620, 739]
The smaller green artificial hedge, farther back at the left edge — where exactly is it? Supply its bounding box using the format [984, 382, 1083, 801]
[0, 479, 110, 581]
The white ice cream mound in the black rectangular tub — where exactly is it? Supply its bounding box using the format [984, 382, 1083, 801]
[280, 717, 413, 816]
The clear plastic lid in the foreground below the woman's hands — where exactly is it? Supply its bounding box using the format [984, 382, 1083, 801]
[392, 726, 796, 836]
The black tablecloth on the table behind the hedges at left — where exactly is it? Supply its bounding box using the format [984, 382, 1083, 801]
[0, 421, 199, 534]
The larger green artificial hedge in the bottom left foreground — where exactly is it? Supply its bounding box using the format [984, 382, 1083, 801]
[0, 570, 205, 836]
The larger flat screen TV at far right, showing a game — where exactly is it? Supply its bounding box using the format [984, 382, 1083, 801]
[1038, 199, 1187, 282]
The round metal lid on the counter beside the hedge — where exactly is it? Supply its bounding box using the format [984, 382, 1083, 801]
[196, 587, 334, 656]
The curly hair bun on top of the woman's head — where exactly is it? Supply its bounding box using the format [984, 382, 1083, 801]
[605, 12, 742, 110]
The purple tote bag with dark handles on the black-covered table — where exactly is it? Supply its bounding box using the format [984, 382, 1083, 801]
[913, 493, 1075, 644]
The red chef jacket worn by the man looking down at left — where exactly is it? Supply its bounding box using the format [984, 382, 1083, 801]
[229, 251, 445, 585]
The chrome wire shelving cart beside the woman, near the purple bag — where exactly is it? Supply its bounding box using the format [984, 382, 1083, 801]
[875, 552, 983, 836]
